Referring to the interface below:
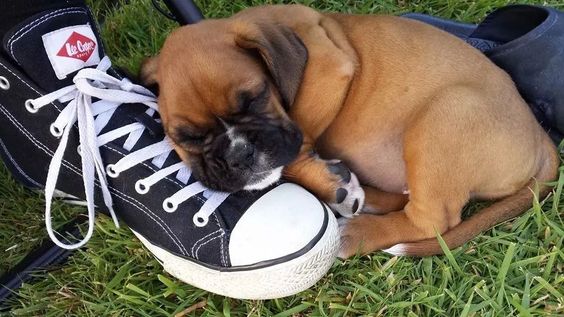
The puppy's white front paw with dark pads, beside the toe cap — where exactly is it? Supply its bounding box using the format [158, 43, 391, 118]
[327, 161, 364, 218]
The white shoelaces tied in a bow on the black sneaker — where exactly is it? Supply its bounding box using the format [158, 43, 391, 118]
[25, 57, 228, 249]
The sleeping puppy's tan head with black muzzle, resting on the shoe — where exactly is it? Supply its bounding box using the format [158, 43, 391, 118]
[141, 19, 307, 192]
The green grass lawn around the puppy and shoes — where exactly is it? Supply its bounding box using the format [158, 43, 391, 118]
[0, 0, 564, 317]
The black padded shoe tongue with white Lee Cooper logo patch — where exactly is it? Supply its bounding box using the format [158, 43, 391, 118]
[3, 7, 104, 92]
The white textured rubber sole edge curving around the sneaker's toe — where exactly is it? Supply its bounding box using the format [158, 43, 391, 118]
[132, 212, 340, 299]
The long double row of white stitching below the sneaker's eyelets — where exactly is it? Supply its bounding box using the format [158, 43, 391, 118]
[0, 104, 188, 255]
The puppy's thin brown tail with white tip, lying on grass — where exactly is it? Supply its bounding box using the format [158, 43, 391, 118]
[384, 136, 560, 256]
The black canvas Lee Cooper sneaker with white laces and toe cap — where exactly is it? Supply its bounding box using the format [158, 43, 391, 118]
[0, 7, 339, 299]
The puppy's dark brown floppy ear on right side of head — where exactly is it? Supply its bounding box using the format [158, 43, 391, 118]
[235, 22, 308, 109]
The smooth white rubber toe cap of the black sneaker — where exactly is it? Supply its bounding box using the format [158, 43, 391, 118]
[229, 183, 328, 266]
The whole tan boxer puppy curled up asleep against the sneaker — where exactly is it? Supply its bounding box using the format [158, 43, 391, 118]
[141, 5, 559, 257]
